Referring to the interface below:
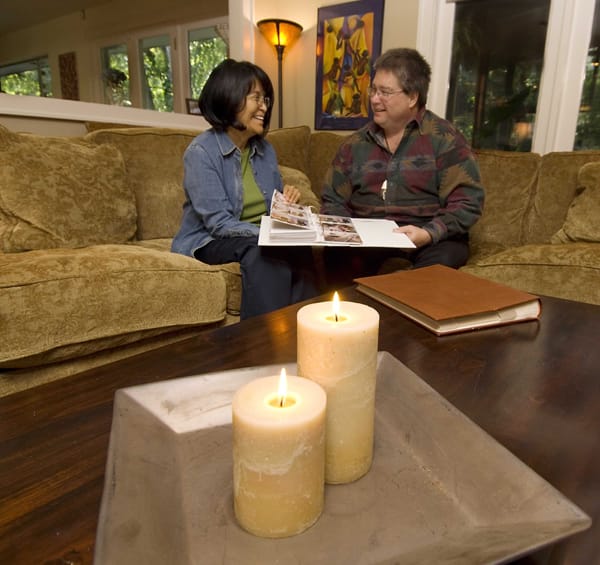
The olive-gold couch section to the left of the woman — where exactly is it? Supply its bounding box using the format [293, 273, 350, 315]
[0, 126, 317, 375]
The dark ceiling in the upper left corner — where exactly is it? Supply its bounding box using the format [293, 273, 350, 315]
[0, 0, 112, 35]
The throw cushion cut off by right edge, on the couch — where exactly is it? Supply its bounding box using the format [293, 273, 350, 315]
[551, 163, 600, 243]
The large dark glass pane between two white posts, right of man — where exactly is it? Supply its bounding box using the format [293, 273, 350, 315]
[446, 0, 550, 151]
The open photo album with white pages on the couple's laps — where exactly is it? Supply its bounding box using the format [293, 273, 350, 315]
[258, 191, 415, 249]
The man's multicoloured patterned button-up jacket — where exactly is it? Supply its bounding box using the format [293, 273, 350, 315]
[321, 108, 484, 243]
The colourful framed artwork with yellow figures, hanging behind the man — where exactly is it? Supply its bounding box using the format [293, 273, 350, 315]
[315, 0, 384, 130]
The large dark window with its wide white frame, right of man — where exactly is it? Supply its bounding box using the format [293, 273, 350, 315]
[417, 0, 600, 153]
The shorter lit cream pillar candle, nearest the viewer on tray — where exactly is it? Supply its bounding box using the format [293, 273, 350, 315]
[232, 371, 327, 538]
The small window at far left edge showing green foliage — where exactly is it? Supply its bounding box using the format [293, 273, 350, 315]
[0, 57, 52, 96]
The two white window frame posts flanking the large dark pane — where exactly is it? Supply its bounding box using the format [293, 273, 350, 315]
[417, 0, 595, 154]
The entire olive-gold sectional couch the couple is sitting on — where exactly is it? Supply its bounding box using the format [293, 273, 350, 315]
[0, 124, 600, 384]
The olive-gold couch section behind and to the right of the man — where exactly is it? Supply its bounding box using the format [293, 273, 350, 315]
[292, 132, 600, 305]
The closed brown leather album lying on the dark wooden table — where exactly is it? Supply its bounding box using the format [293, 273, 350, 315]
[355, 265, 541, 335]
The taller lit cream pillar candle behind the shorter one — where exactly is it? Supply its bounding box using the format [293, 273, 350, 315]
[297, 293, 379, 483]
